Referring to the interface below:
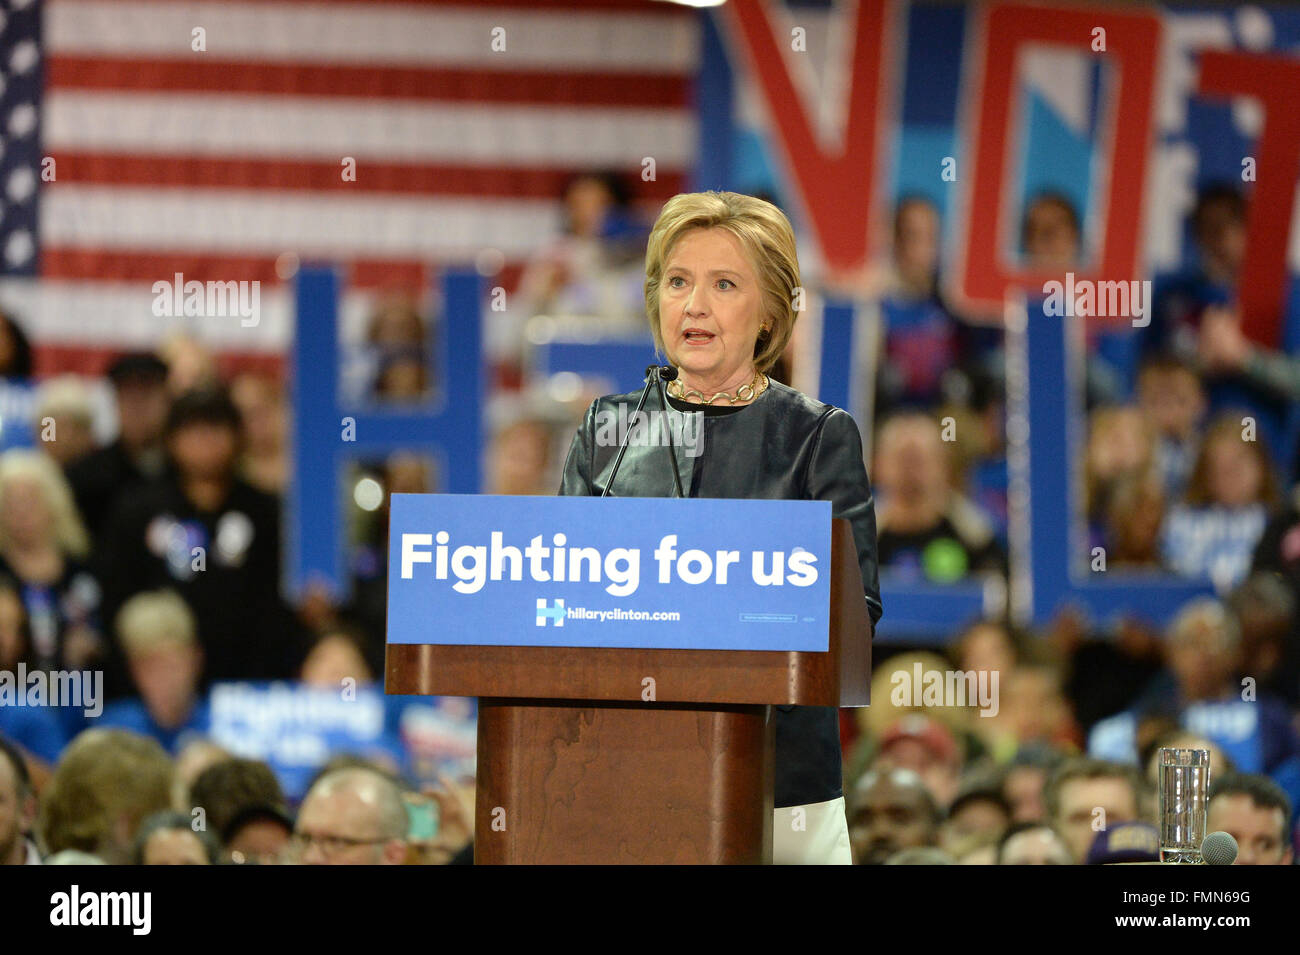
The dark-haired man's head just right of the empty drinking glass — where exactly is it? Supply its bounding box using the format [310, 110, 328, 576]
[1205, 773, 1295, 865]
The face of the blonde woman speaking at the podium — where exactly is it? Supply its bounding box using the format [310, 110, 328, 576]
[659, 229, 762, 392]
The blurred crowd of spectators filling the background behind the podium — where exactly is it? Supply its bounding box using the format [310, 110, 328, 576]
[0, 174, 1300, 864]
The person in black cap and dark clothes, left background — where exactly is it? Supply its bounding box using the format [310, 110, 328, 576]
[66, 352, 170, 538]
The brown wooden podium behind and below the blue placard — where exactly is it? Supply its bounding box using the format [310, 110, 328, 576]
[385, 520, 871, 864]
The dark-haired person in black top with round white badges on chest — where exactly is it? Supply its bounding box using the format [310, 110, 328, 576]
[98, 390, 302, 682]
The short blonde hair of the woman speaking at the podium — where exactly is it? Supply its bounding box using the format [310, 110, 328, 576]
[646, 192, 801, 372]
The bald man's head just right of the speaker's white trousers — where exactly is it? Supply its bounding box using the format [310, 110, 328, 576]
[849, 769, 943, 865]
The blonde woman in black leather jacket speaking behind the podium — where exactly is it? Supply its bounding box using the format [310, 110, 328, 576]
[560, 192, 880, 864]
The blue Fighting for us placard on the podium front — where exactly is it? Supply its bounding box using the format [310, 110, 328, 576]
[387, 494, 831, 652]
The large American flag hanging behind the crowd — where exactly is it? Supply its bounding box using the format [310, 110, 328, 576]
[0, 0, 699, 373]
